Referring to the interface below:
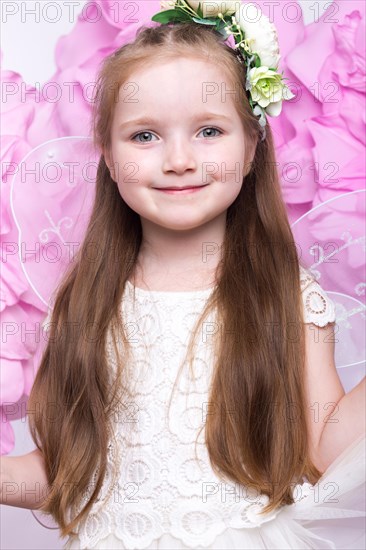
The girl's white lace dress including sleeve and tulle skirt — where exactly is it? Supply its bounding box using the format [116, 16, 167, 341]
[64, 268, 365, 550]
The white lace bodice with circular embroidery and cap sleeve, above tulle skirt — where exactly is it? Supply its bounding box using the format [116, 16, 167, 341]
[65, 268, 335, 548]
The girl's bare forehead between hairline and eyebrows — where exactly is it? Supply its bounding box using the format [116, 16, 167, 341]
[116, 57, 239, 118]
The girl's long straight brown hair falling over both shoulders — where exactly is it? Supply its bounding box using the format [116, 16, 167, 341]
[28, 22, 321, 536]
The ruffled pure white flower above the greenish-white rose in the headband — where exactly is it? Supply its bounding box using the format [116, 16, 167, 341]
[235, 3, 281, 69]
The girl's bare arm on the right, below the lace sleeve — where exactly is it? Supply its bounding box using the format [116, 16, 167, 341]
[305, 323, 365, 472]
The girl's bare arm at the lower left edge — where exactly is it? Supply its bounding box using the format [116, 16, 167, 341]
[0, 449, 49, 510]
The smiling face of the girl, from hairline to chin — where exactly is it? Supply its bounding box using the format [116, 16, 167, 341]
[104, 58, 254, 230]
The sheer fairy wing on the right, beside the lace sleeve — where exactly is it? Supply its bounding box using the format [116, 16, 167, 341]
[292, 190, 366, 392]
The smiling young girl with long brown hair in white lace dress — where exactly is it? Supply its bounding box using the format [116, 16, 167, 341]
[1, 2, 364, 549]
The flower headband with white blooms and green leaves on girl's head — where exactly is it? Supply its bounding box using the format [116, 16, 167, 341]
[151, 0, 295, 141]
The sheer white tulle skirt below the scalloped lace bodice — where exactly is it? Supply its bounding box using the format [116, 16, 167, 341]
[64, 435, 366, 550]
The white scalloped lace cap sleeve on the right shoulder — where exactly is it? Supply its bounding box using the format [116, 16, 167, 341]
[300, 266, 336, 327]
